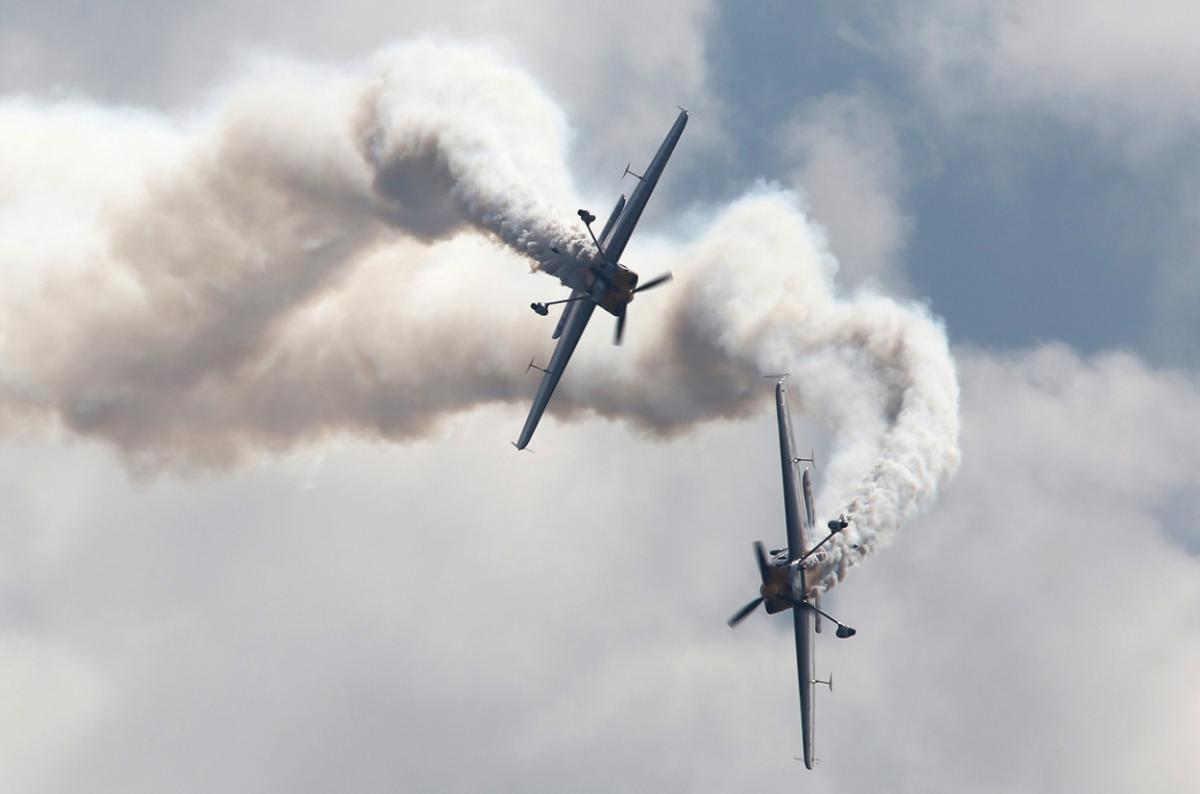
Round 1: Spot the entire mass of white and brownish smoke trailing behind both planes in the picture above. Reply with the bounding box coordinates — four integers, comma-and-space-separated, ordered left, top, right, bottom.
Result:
0, 43, 958, 587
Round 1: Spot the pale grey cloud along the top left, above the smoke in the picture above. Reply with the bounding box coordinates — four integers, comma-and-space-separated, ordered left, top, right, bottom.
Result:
0, 0, 722, 187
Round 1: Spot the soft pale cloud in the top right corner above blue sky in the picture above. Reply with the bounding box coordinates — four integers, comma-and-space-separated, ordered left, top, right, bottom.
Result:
881, 0, 1200, 160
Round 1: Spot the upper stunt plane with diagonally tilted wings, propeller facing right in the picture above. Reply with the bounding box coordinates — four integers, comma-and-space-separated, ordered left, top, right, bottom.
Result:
512, 108, 688, 450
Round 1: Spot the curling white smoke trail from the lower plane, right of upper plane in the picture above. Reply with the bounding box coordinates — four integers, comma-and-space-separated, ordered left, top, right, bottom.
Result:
590, 188, 959, 589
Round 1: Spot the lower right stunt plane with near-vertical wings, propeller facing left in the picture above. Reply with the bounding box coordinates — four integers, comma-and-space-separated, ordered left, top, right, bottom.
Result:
728, 374, 856, 769
